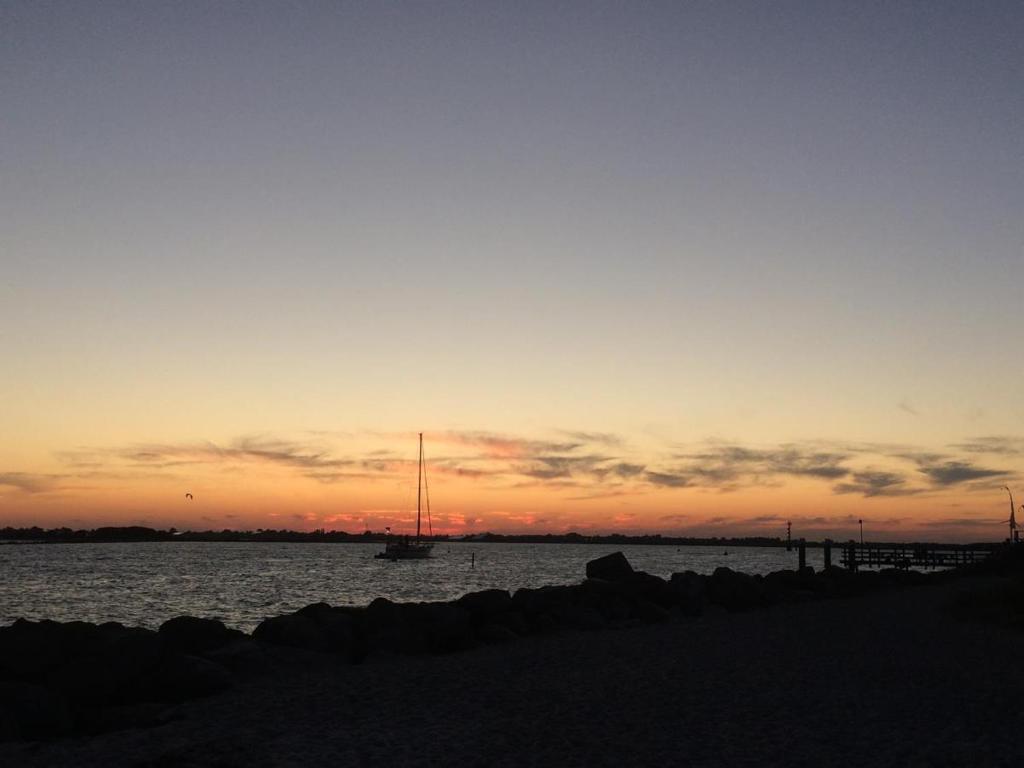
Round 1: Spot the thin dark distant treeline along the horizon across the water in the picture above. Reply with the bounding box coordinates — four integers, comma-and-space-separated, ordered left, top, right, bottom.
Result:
0, 525, 998, 548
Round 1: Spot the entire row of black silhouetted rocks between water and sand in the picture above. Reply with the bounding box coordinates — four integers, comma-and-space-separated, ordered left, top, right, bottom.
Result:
0, 545, 1024, 755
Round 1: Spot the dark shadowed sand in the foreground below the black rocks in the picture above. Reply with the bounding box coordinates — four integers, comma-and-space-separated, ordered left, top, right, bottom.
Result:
0, 579, 1024, 766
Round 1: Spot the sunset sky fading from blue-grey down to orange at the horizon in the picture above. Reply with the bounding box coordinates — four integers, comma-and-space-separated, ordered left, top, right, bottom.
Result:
0, 0, 1024, 541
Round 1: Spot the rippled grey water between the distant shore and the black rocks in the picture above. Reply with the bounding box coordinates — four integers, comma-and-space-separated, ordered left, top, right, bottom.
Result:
0, 542, 821, 631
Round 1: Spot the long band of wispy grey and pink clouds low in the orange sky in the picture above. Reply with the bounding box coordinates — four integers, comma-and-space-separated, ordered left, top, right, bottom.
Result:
29, 430, 1024, 501
